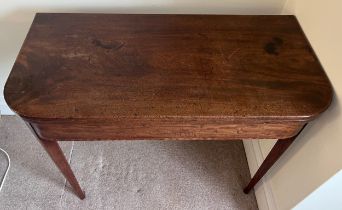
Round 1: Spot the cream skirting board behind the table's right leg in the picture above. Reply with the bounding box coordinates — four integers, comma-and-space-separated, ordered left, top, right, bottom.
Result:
243, 140, 279, 210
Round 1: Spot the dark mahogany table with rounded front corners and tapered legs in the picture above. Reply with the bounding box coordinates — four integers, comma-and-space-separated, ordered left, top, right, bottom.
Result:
4, 13, 332, 199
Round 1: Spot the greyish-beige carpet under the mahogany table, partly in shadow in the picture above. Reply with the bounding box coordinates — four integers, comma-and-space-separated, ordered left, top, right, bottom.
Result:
0, 116, 257, 210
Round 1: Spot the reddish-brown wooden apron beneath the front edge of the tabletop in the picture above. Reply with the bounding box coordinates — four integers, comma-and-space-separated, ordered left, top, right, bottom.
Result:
30, 119, 304, 141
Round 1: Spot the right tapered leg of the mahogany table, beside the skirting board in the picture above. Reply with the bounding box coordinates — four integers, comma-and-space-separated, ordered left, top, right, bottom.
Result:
243, 125, 305, 194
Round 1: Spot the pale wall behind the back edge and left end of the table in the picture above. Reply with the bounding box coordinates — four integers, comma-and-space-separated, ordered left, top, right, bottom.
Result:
0, 0, 285, 114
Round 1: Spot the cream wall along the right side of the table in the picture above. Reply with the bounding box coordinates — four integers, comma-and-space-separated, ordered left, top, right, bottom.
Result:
245, 0, 342, 209
